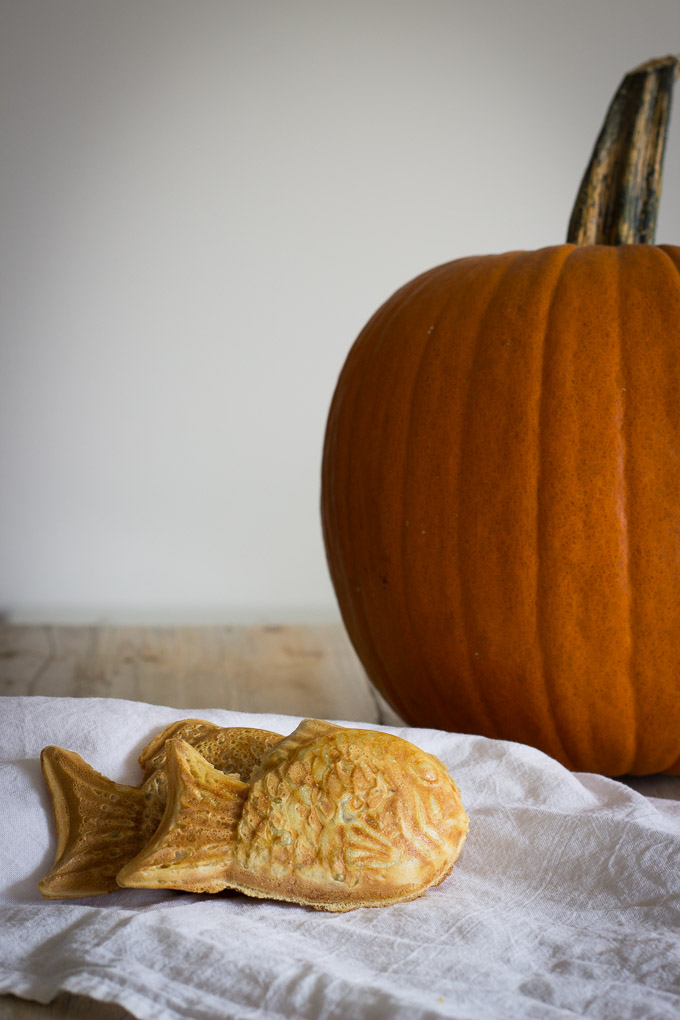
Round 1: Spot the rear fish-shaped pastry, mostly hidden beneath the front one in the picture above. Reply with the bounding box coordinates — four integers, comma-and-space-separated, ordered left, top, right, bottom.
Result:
38, 719, 282, 900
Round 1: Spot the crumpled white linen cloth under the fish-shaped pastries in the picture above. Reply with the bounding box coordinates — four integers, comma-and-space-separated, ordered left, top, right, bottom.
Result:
0, 697, 680, 1020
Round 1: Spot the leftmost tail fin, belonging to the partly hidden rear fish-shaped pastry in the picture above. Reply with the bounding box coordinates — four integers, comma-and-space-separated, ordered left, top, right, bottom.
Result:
38, 747, 146, 900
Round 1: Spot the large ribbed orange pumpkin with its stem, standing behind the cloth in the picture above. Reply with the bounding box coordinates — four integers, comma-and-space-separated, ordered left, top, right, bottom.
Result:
322, 58, 680, 775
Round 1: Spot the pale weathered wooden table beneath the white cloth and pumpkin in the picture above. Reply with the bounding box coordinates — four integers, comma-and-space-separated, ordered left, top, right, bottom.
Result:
0, 624, 680, 1020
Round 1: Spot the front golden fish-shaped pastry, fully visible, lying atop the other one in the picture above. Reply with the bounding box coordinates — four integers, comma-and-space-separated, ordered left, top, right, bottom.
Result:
117, 719, 468, 911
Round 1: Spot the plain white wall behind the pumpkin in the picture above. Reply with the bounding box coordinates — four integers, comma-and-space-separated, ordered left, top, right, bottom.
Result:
0, 0, 680, 622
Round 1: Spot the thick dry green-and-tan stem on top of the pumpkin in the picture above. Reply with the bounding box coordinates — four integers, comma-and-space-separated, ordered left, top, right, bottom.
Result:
567, 56, 680, 245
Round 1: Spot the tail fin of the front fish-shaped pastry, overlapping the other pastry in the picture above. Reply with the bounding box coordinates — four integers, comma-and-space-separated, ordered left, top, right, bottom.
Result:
117, 738, 250, 893
